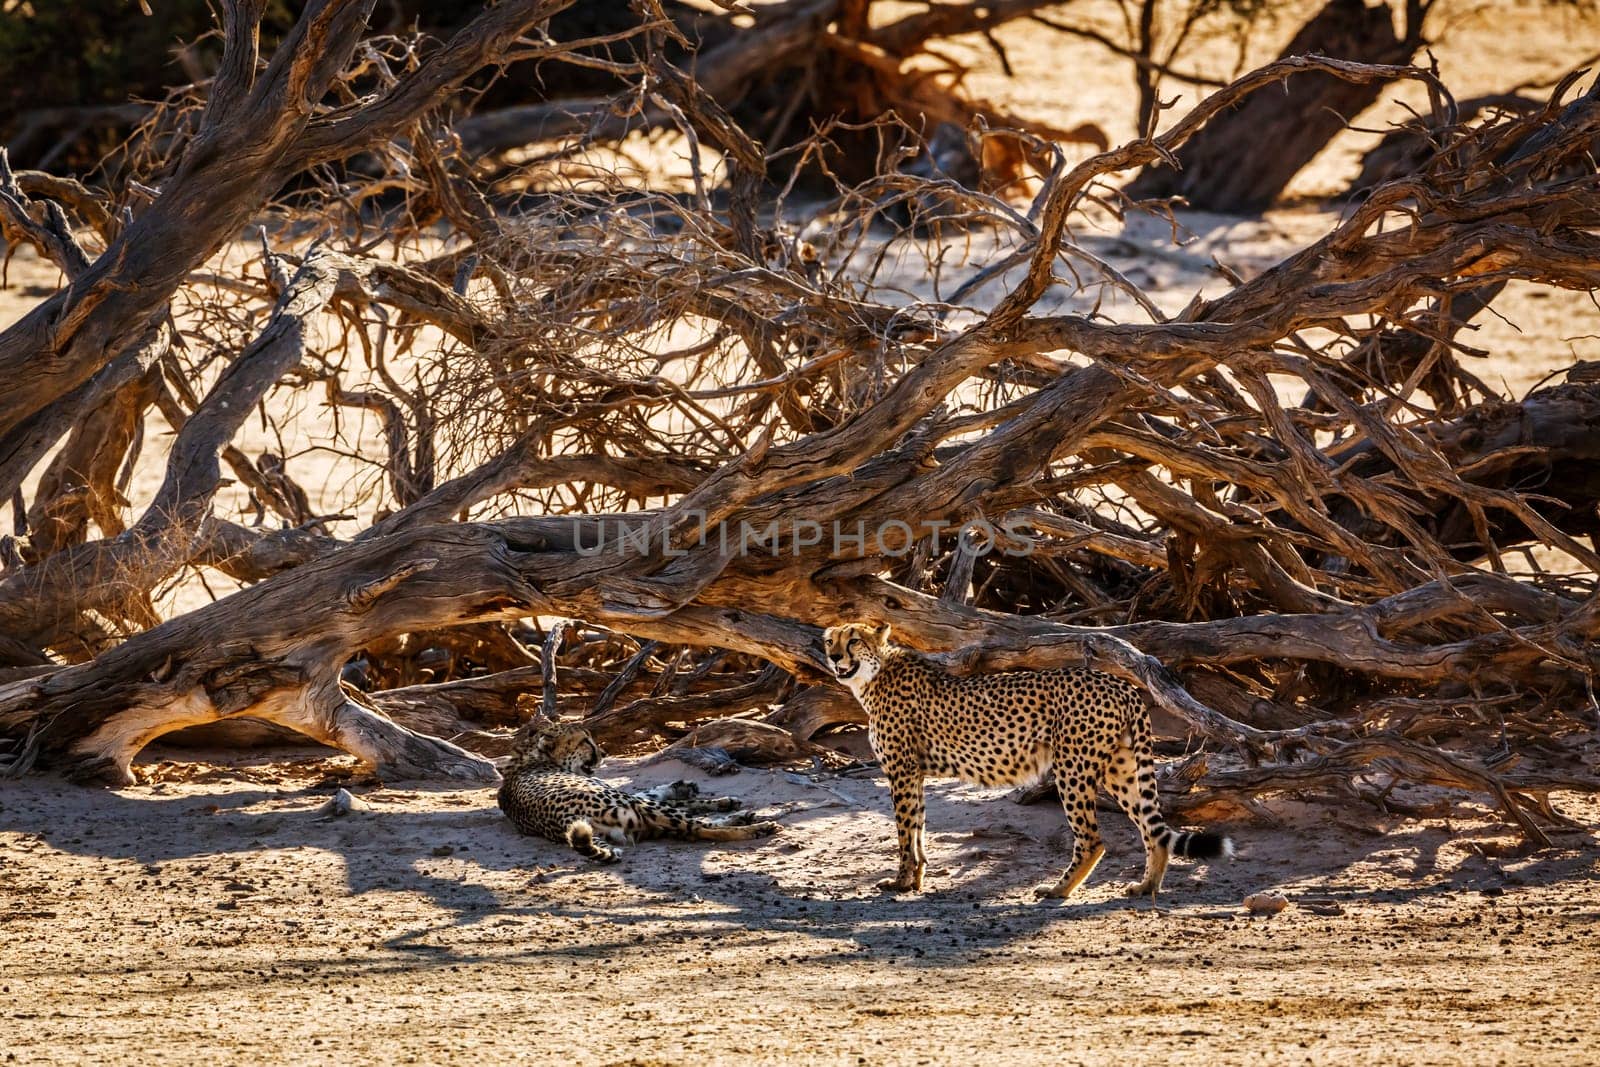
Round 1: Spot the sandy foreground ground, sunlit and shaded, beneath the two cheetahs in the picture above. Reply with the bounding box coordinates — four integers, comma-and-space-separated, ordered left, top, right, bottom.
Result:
0, 753, 1600, 1064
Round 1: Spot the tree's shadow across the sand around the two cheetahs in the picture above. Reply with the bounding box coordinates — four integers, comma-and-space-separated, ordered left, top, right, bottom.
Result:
0, 751, 1595, 966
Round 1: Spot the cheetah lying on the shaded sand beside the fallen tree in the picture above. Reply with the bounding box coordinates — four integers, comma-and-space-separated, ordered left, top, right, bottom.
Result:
499, 718, 778, 864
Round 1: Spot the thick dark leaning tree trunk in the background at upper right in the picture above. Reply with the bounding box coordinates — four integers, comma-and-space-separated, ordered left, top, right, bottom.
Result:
1126, 0, 1426, 214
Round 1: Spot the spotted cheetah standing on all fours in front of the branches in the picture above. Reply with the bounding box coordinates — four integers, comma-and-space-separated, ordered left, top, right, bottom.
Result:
822, 624, 1234, 897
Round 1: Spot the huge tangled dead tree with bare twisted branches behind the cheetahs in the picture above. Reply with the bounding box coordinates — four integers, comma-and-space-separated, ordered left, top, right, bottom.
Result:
0, 3, 1600, 837
